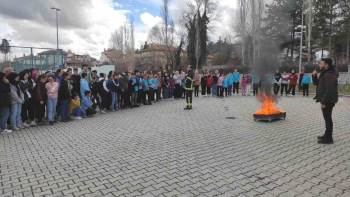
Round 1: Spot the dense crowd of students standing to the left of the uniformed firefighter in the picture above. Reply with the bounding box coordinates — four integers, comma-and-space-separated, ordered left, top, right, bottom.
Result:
0, 66, 201, 133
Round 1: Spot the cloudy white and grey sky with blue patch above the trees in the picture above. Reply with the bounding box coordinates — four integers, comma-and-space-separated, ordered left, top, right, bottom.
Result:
0, 0, 238, 58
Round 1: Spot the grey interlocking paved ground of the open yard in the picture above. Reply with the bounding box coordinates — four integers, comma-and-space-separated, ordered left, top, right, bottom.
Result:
0, 97, 350, 197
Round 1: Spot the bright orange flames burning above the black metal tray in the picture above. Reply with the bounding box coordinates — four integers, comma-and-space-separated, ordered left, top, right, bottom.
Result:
255, 93, 284, 115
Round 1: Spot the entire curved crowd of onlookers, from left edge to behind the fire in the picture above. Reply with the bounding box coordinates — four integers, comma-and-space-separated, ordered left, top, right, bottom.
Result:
0, 63, 317, 132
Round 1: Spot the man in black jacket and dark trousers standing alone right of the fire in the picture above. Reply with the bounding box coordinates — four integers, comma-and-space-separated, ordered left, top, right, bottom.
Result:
316, 58, 338, 144
